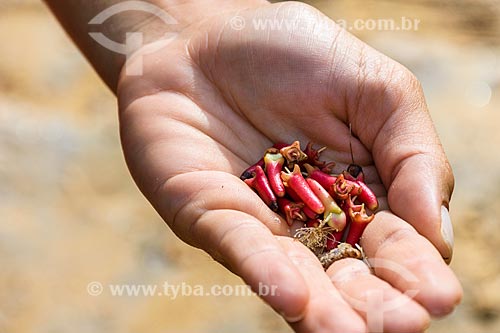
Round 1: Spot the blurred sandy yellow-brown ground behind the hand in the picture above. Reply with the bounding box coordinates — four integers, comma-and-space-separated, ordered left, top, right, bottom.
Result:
0, 0, 500, 333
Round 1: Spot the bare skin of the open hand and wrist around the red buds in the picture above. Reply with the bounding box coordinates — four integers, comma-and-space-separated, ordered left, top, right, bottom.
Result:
47, 0, 462, 332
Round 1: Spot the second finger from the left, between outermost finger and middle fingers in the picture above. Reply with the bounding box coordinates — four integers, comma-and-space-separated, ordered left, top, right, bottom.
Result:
278, 237, 366, 333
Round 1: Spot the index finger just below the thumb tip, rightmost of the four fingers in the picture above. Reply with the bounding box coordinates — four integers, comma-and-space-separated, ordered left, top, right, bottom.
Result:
361, 211, 462, 316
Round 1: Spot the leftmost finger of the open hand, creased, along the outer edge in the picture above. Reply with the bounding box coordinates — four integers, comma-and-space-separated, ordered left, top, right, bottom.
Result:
154, 171, 308, 320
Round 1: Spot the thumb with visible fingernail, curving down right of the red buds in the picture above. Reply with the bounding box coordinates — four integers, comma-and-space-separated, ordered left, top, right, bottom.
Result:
363, 71, 454, 263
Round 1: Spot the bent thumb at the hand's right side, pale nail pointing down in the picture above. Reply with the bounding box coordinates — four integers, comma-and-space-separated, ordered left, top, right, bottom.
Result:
353, 61, 454, 262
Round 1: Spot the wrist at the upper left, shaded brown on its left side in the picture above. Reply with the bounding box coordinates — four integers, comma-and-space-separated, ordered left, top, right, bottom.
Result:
45, 0, 268, 92
